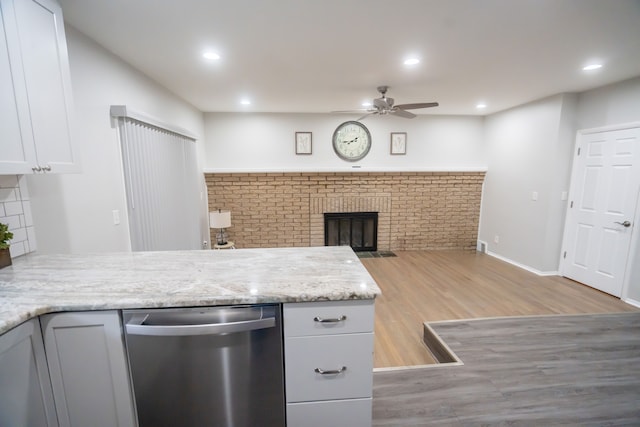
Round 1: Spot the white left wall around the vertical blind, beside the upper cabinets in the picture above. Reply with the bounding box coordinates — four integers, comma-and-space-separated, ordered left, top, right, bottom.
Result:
27, 27, 206, 253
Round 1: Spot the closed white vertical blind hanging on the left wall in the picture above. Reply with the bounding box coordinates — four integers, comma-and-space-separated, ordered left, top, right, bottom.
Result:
118, 117, 201, 251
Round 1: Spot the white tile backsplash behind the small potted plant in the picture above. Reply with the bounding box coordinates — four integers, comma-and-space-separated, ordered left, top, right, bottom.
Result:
0, 175, 37, 258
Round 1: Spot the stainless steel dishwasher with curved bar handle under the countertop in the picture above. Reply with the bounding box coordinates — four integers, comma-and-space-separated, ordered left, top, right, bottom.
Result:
123, 304, 285, 427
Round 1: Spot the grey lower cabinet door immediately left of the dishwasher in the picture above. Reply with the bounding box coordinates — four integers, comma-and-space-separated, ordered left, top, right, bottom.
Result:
41, 311, 136, 427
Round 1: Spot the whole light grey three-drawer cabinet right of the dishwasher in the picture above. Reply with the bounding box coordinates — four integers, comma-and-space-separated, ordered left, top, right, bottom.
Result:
283, 300, 374, 427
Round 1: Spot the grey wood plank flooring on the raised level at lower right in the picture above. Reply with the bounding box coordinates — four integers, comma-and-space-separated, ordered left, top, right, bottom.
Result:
373, 312, 640, 427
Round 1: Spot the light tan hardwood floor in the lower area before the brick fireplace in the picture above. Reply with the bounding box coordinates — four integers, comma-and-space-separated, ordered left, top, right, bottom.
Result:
362, 251, 640, 368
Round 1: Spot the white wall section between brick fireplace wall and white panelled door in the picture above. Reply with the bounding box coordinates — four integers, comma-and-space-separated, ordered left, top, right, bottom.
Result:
479, 95, 576, 274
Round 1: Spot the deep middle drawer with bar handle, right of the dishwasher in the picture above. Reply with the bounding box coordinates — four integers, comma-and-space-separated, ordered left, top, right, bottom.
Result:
285, 333, 373, 402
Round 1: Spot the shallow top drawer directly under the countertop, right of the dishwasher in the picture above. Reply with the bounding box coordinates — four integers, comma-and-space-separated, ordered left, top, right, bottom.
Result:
283, 300, 374, 337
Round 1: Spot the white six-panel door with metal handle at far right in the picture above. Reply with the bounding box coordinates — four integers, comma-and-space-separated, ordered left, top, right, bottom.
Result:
561, 127, 640, 297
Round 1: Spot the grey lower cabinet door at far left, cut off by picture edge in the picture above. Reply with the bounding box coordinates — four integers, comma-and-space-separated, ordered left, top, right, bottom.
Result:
0, 319, 58, 427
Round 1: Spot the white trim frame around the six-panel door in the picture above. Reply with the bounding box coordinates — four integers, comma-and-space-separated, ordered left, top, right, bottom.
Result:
559, 122, 640, 305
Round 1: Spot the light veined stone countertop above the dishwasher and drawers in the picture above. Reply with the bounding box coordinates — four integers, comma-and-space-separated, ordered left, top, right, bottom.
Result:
0, 246, 380, 334
